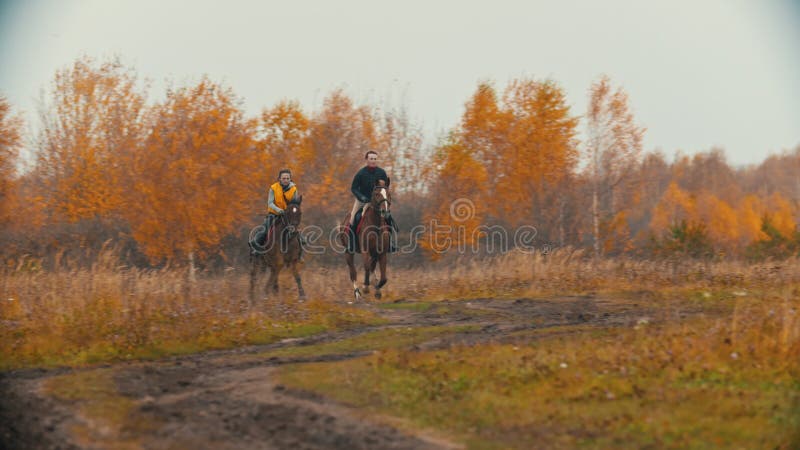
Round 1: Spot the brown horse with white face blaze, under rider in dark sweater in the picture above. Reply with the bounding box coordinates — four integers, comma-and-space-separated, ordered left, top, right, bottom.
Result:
339, 180, 392, 301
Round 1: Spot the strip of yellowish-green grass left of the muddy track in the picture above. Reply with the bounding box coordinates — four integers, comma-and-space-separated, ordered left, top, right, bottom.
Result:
0, 298, 386, 370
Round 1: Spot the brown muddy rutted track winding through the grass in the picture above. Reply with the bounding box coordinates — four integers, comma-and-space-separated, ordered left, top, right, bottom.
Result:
0, 296, 708, 450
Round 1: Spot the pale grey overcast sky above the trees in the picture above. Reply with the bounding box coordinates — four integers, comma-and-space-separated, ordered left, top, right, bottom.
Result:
0, 0, 800, 165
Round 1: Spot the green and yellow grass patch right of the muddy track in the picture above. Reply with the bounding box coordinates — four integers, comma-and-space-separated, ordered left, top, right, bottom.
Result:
279, 299, 800, 449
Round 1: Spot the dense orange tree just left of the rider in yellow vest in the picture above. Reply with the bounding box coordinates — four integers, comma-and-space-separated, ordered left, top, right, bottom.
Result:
126, 78, 264, 268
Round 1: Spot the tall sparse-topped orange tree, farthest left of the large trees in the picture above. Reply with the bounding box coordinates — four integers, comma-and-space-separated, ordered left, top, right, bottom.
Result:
36, 57, 145, 229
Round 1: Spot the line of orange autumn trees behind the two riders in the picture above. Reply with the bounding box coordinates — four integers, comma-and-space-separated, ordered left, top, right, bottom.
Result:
0, 57, 800, 266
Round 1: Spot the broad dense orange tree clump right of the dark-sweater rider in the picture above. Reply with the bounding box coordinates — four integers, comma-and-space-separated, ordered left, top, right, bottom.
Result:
426, 79, 578, 256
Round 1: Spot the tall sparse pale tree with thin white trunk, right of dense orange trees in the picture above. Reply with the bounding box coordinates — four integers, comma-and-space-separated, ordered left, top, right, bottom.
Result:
586, 76, 644, 255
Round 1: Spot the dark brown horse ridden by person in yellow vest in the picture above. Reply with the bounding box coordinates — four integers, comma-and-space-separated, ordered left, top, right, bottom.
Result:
250, 196, 306, 300
